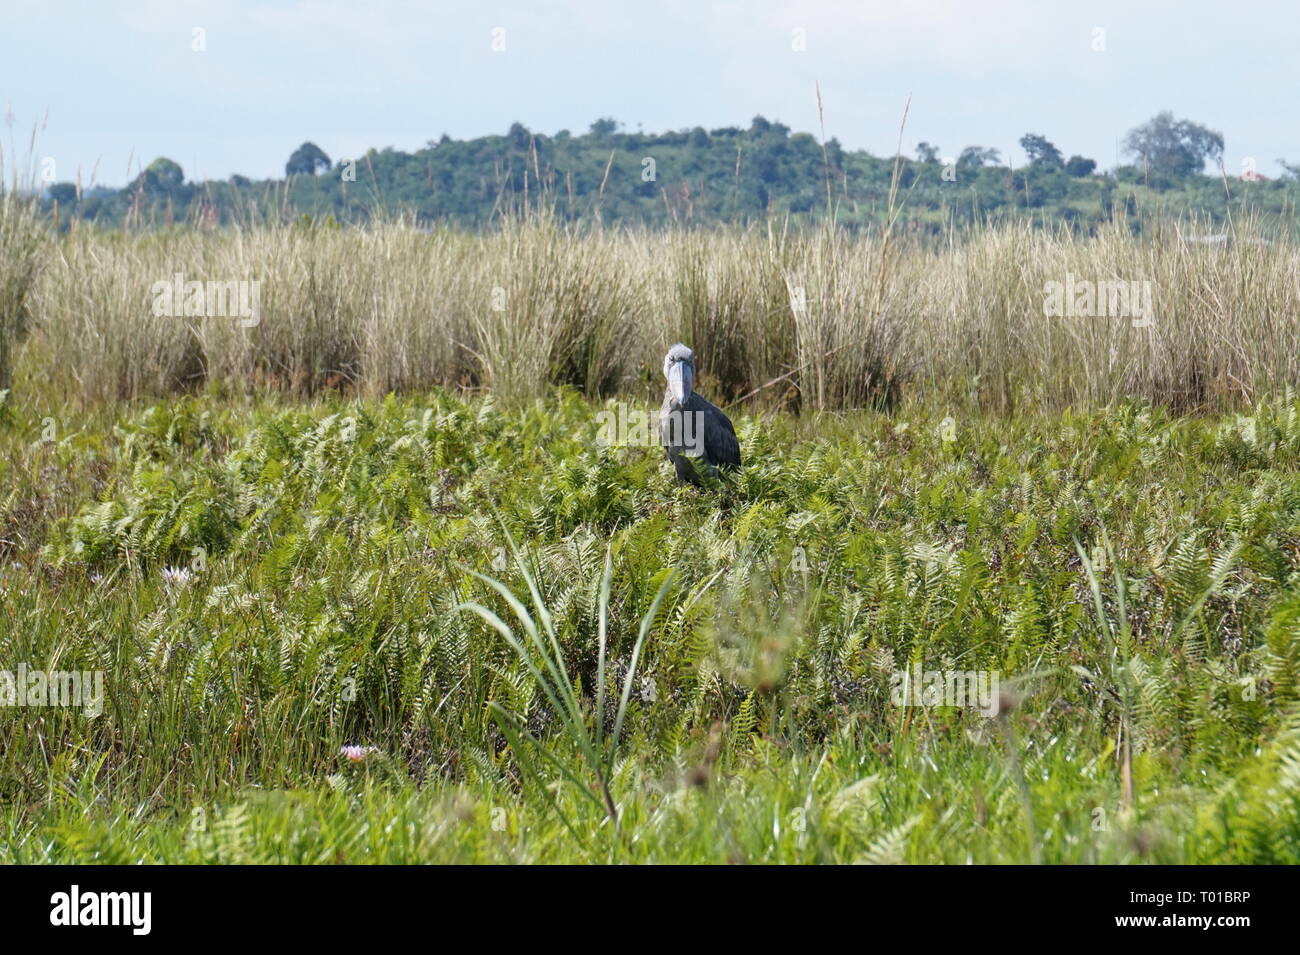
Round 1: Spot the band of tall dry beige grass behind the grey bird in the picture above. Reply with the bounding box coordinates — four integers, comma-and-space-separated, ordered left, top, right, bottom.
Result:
15, 213, 1300, 412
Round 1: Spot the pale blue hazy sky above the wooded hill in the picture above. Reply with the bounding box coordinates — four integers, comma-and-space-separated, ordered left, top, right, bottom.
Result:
0, 0, 1300, 186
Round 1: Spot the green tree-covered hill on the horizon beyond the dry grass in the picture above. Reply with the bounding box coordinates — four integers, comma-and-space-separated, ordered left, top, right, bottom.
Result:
44, 113, 1300, 231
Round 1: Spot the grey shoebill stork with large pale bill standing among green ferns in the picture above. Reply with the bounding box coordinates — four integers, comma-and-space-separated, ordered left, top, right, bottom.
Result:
659, 344, 740, 485
